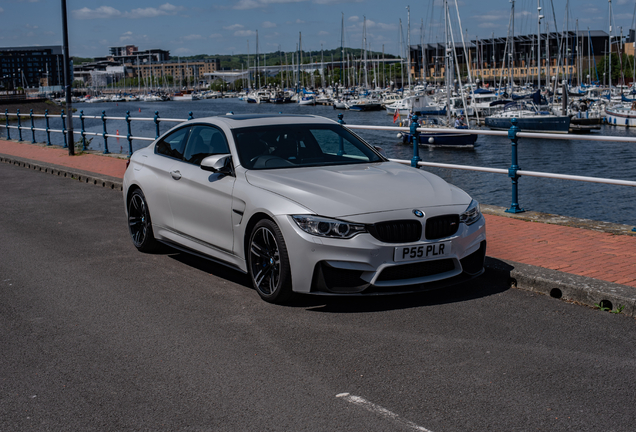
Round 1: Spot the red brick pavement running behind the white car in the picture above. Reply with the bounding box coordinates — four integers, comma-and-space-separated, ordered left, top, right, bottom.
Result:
0, 140, 636, 287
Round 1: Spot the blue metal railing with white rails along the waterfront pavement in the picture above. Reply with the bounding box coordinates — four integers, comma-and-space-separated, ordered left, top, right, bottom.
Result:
0, 110, 636, 232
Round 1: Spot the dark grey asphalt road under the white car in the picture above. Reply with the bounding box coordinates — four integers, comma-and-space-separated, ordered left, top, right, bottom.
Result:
0, 164, 636, 432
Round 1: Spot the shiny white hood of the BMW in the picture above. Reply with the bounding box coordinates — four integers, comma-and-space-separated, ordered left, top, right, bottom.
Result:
246, 162, 470, 217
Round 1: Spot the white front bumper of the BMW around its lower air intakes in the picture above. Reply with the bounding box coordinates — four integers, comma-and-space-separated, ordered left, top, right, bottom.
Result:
277, 210, 486, 295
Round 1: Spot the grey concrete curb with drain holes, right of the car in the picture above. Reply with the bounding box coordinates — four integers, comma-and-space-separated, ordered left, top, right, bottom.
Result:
485, 257, 636, 317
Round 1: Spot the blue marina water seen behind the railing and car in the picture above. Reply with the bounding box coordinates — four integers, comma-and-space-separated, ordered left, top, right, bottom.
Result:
27, 98, 636, 226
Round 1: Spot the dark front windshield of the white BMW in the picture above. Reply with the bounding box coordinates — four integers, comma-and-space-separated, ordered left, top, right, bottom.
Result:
233, 124, 383, 170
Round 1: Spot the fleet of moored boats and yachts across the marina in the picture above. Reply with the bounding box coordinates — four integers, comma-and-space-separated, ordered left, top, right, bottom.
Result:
74, 85, 636, 147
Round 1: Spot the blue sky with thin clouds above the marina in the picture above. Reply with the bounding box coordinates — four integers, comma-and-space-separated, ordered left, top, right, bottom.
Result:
0, 0, 635, 57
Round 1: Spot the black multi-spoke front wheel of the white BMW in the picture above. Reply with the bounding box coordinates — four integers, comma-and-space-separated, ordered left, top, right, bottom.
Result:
247, 219, 292, 303
